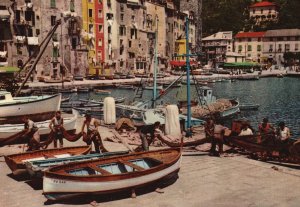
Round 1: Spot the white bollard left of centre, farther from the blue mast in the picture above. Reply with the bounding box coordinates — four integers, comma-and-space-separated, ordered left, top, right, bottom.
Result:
103, 97, 116, 124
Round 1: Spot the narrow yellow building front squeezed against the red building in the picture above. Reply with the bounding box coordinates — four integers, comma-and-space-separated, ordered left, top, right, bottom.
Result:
82, 0, 96, 75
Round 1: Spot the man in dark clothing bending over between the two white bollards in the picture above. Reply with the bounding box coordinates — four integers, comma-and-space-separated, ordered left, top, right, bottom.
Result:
140, 121, 160, 151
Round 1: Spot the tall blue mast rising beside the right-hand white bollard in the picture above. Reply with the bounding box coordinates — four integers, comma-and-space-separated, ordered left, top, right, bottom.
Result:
185, 16, 192, 136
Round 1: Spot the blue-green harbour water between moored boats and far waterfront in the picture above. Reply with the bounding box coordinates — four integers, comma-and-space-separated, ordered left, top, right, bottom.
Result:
68, 77, 300, 138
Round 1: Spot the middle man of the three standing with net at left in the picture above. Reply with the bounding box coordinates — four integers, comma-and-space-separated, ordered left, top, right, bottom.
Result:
49, 111, 64, 148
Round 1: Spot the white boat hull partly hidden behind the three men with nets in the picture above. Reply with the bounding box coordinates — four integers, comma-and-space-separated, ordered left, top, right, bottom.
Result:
0, 113, 78, 142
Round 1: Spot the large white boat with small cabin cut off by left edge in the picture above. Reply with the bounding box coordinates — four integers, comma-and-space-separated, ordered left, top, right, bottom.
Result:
0, 91, 61, 124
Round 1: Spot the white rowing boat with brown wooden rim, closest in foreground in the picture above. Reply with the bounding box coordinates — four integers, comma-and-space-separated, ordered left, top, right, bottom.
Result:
43, 148, 181, 200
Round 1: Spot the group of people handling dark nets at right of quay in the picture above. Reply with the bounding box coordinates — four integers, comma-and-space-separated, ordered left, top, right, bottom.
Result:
205, 118, 291, 156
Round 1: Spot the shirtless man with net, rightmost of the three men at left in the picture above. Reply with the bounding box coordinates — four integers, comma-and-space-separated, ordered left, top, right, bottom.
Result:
81, 114, 102, 153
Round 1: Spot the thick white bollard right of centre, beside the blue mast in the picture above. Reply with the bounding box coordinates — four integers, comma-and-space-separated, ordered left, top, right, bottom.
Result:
165, 105, 181, 137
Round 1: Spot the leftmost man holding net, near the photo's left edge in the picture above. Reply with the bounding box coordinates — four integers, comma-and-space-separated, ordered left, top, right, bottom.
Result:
22, 116, 40, 151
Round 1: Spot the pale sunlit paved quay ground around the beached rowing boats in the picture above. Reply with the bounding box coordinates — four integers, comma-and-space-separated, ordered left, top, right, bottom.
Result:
0, 139, 300, 207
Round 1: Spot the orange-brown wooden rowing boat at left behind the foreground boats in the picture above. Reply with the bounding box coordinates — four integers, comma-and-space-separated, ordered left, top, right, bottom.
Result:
4, 146, 91, 175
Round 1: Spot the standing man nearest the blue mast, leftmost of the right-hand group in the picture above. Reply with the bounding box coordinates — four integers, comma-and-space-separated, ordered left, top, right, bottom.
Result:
209, 119, 227, 157
